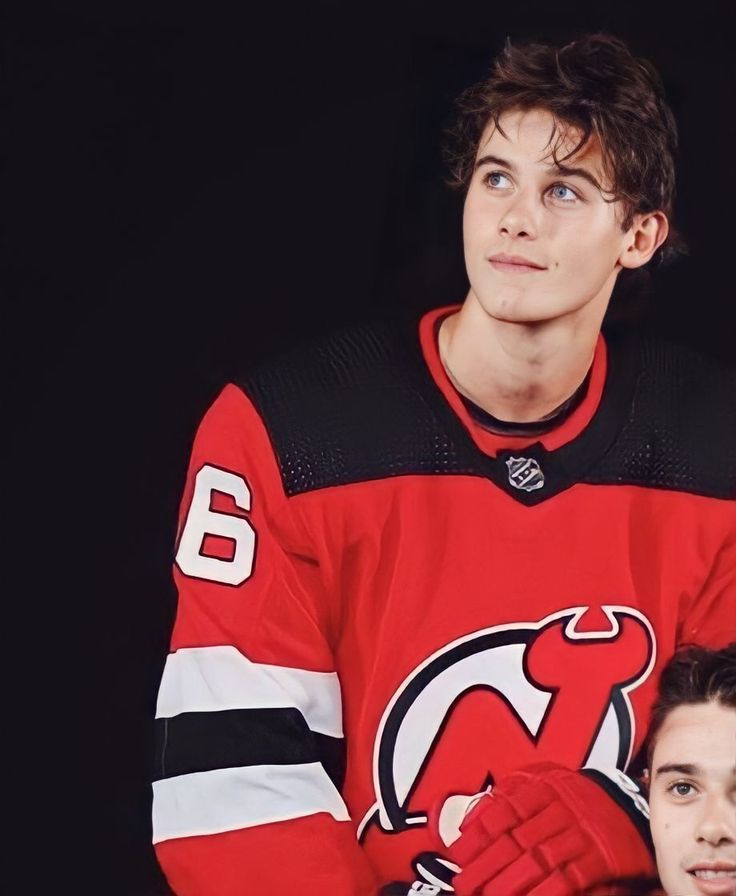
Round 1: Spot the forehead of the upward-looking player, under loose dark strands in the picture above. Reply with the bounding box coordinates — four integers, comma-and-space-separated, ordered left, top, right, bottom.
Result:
476, 109, 604, 174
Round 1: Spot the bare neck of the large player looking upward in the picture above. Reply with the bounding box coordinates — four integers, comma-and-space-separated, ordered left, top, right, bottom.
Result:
439, 290, 602, 423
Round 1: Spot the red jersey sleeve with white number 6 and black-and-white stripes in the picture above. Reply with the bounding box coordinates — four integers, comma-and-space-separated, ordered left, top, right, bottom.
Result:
153, 385, 377, 896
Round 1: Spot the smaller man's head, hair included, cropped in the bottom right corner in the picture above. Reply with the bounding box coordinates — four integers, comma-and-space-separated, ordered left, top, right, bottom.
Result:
648, 643, 736, 896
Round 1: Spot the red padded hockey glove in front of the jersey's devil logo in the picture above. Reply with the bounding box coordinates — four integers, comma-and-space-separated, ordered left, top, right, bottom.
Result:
449, 763, 656, 896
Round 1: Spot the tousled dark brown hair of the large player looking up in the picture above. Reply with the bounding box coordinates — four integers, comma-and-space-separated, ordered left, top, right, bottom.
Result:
445, 34, 686, 261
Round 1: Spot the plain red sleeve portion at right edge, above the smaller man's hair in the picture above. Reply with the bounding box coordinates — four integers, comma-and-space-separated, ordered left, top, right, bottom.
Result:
678, 520, 736, 649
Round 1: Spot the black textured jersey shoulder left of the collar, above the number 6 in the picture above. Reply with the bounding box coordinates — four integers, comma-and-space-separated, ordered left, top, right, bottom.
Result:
235, 312, 466, 496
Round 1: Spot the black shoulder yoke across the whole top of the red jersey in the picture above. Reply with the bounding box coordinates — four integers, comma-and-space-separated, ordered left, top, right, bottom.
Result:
236, 318, 736, 505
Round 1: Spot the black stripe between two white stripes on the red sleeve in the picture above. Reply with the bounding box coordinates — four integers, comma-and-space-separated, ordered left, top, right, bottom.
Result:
155, 707, 345, 790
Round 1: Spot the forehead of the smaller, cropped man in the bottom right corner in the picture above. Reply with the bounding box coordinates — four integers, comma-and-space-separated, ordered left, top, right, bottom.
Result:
652, 702, 736, 769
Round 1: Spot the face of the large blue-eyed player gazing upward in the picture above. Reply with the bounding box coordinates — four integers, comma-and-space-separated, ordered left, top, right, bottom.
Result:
463, 109, 631, 323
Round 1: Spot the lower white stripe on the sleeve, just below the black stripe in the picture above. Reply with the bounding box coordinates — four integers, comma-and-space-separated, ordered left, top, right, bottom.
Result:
153, 762, 350, 843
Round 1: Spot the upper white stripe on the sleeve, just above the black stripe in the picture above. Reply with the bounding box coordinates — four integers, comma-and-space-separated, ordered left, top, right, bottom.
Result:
156, 645, 343, 737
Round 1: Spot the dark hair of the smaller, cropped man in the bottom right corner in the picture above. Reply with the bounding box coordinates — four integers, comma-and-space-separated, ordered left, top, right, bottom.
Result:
646, 641, 736, 766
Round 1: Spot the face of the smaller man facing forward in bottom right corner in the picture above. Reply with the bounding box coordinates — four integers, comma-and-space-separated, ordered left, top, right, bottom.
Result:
649, 702, 736, 896
